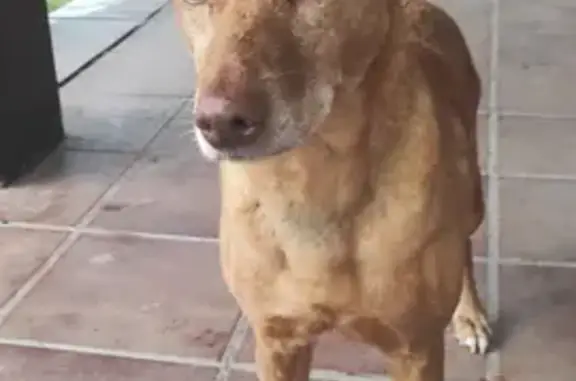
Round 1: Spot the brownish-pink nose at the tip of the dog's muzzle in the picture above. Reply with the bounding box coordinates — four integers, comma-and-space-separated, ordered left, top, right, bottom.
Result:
196, 95, 264, 149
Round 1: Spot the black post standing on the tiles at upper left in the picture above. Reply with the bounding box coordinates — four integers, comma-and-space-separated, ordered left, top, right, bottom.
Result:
0, 0, 64, 186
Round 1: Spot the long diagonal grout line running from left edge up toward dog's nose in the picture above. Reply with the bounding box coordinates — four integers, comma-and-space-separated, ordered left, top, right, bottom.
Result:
0, 101, 185, 327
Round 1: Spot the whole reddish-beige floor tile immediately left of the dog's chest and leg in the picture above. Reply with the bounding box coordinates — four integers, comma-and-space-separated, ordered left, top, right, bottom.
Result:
0, 236, 238, 358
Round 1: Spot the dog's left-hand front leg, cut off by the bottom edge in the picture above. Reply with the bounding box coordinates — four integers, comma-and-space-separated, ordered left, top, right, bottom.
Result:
255, 329, 313, 381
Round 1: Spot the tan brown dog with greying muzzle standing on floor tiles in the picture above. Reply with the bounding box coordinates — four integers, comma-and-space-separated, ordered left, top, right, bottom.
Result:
175, 0, 489, 381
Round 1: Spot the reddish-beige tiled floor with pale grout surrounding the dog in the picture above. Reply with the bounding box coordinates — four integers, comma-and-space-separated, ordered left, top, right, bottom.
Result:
0, 0, 576, 381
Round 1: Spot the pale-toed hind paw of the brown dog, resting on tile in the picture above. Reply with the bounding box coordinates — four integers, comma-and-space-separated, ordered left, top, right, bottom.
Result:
452, 314, 492, 355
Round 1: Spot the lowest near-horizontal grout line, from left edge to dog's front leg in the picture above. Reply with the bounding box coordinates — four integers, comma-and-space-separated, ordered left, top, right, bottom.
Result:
0, 338, 220, 368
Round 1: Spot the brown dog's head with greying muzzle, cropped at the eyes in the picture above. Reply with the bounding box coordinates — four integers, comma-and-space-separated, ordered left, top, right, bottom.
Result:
174, 0, 391, 159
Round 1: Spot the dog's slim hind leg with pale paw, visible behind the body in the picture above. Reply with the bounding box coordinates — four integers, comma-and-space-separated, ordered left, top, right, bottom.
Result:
452, 240, 491, 354
